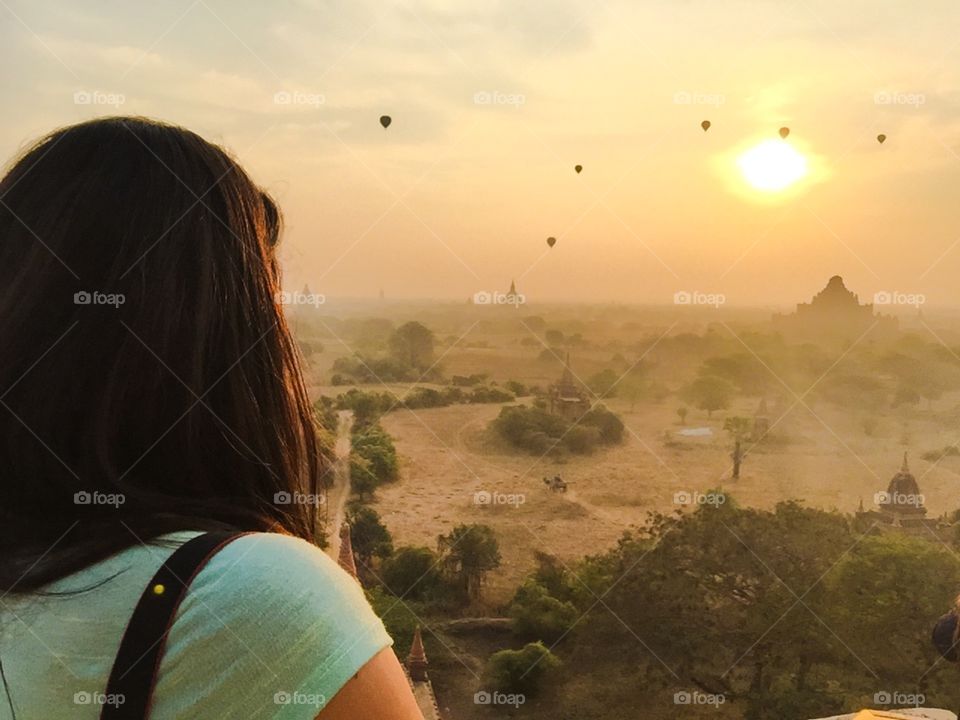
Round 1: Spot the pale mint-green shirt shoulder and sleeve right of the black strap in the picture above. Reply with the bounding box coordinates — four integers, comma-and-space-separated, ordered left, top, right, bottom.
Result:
154, 533, 391, 719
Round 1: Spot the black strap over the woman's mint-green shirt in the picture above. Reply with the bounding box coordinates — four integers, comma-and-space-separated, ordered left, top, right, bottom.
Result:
100, 532, 248, 720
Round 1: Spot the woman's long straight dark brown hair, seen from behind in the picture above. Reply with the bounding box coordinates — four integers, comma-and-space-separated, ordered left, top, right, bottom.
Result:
0, 117, 325, 592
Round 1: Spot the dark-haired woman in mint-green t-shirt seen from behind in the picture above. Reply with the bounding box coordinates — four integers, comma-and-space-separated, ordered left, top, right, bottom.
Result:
0, 118, 421, 720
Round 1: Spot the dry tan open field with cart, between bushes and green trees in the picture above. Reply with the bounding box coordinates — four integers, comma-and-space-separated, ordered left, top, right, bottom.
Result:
366, 398, 960, 605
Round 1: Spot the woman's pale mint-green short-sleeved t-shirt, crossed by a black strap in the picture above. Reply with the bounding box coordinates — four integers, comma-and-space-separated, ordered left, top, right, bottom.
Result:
0, 532, 391, 720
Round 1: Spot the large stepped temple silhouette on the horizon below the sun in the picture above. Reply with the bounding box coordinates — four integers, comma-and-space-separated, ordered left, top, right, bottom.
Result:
773, 275, 899, 342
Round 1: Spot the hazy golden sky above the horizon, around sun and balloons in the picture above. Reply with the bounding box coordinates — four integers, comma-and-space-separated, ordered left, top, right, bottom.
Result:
0, 0, 960, 305
